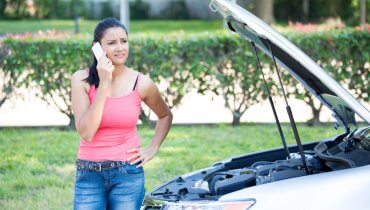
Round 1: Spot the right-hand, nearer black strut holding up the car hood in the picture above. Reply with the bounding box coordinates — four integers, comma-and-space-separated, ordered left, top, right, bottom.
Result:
265, 39, 310, 175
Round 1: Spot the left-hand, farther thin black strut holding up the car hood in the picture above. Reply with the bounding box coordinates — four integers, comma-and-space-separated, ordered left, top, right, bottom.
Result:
251, 42, 290, 159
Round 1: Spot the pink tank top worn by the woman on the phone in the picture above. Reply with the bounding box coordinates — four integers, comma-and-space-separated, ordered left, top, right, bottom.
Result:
78, 69, 141, 161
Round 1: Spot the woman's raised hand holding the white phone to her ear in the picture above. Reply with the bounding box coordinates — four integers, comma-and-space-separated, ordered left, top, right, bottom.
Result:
96, 54, 114, 87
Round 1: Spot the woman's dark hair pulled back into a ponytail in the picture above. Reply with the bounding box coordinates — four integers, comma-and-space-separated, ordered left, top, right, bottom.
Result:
84, 17, 127, 88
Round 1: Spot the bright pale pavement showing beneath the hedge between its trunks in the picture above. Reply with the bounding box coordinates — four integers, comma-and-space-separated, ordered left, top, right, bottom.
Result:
0, 88, 348, 126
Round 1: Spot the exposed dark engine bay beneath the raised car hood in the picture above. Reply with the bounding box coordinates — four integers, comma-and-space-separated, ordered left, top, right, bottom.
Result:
150, 127, 370, 201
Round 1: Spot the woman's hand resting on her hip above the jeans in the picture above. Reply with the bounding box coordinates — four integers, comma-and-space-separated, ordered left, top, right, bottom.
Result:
127, 146, 158, 167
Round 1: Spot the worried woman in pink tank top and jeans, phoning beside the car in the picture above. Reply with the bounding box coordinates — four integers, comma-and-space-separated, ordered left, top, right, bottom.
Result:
72, 18, 172, 210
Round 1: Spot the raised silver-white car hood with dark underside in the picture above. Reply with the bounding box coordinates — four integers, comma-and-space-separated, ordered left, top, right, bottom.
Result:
210, 0, 370, 127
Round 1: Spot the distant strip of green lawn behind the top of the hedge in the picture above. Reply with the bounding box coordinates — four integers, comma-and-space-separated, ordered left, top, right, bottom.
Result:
0, 20, 223, 34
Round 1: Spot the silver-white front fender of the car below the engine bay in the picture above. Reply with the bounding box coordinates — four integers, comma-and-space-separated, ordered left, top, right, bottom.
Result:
220, 165, 370, 210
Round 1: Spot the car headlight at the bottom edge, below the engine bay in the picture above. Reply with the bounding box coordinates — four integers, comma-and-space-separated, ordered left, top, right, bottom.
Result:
161, 199, 256, 210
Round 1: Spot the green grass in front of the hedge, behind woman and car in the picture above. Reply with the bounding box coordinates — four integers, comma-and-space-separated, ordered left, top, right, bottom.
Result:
0, 124, 341, 209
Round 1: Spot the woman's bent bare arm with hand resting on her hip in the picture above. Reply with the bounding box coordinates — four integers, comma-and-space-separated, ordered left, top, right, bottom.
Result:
127, 74, 172, 167
